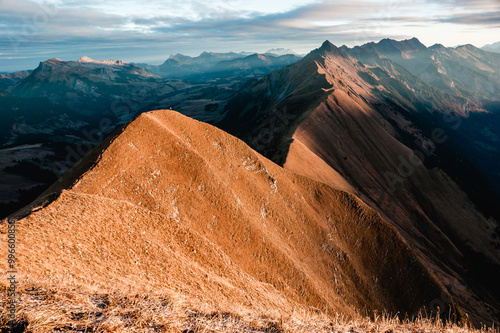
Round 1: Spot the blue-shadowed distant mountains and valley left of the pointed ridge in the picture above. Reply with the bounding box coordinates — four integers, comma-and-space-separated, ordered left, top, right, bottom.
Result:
0, 52, 299, 215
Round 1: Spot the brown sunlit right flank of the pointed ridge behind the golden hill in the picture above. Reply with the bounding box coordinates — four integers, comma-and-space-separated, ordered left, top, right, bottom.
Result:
282, 54, 500, 323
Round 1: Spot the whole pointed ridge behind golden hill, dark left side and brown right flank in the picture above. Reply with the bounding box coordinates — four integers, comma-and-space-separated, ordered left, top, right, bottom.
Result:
220, 42, 500, 322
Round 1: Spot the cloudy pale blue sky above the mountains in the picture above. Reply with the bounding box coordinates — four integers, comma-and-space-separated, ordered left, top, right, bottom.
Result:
0, 0, 500, 72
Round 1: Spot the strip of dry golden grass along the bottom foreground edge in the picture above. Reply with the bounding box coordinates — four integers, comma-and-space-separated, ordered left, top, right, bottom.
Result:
0, 286, 500, 333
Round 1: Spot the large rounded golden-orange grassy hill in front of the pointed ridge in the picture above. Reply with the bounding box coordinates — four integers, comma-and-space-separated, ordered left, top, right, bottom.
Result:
0, 111, 452, 322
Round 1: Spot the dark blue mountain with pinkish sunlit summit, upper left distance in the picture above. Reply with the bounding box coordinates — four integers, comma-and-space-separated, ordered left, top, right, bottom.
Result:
11, 57, 179, 122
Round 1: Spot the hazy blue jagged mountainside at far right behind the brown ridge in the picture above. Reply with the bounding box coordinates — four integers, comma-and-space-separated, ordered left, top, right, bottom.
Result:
342, 40, 500, 198
